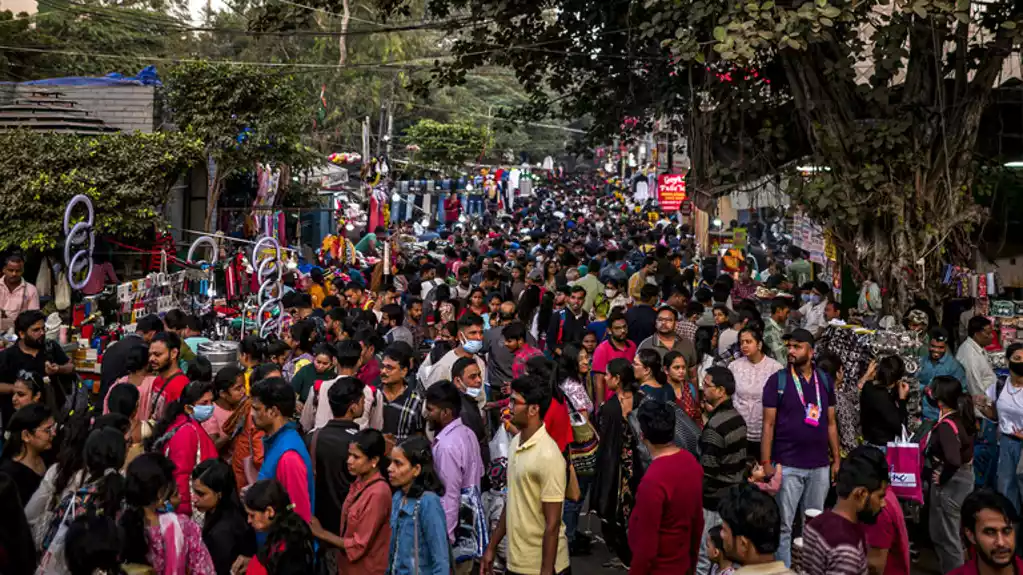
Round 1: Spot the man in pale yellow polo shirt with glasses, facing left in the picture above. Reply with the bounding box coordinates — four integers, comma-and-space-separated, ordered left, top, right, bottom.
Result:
482, 375, 569, 575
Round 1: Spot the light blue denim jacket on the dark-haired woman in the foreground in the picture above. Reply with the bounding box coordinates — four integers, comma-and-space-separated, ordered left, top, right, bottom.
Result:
387, 490, 451, 575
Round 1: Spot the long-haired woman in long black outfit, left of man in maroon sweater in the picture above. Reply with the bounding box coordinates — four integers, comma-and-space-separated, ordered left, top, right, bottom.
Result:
591, 352, 656, 565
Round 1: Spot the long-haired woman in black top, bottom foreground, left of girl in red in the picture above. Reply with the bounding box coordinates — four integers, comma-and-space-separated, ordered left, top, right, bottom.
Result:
191, 459, 256, 575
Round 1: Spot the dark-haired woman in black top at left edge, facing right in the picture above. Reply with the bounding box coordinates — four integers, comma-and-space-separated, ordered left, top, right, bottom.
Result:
0, 403, 56, 505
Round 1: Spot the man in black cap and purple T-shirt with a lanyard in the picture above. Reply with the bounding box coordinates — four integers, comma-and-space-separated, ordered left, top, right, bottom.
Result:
760, 328, 841, 566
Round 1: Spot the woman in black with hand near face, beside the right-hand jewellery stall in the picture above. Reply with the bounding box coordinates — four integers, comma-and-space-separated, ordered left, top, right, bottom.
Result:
859, 355, 909, 451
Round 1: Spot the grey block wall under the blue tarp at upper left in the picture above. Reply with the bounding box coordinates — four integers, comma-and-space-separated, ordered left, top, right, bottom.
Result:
15, 84, 155, 133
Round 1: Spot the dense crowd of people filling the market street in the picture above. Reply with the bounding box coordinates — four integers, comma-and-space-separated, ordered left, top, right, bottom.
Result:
0, 175, 1023, 575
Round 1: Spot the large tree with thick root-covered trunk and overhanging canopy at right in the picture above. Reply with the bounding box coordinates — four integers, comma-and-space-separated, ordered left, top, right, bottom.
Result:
379, 0, 1023, 308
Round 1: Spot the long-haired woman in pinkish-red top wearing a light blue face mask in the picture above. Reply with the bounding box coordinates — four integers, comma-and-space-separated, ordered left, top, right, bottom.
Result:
146, 382, 217, 515
